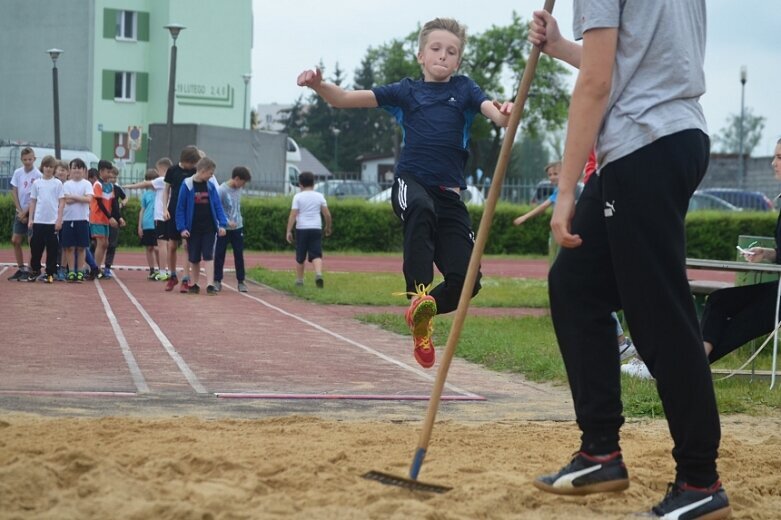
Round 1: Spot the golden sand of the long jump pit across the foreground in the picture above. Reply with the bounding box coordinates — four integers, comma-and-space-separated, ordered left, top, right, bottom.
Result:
0, 415, 781, 520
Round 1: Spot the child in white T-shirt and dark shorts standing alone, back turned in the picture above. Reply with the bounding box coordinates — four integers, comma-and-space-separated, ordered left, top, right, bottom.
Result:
285, 172, 331, 289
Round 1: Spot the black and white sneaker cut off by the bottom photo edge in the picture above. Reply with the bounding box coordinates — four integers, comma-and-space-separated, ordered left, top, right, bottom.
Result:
646, 480, 732, 520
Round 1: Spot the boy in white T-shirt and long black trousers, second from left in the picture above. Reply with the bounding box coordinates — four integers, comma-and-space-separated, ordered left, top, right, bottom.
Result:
27, 155, 65, 283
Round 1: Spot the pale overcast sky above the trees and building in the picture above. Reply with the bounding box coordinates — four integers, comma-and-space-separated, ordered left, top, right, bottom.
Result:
251, 0, 781, 157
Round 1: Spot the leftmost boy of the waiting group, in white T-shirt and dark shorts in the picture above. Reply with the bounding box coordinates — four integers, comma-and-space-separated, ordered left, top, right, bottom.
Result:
8, 147, 41, 281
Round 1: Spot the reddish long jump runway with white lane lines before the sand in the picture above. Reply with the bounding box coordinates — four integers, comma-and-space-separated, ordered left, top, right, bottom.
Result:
0, 267, 494, 400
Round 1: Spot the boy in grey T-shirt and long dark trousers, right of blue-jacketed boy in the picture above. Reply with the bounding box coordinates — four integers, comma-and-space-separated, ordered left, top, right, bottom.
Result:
214, 166, 252, 292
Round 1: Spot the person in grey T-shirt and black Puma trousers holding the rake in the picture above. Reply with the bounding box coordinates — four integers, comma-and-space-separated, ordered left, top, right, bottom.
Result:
529, 0, 730, 520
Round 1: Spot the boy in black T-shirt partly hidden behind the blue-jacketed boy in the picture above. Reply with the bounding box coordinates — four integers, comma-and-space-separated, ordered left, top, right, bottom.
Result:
163, 146, 201, 292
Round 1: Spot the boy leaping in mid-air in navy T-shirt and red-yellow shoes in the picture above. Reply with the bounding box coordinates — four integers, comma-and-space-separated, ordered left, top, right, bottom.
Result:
298, 18, 512, 368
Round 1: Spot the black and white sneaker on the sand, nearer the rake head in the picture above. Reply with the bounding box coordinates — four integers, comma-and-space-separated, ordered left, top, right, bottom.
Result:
534, 451, 629, 495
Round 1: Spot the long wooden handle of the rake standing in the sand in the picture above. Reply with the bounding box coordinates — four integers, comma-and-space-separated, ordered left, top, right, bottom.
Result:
410, 0, 555, 479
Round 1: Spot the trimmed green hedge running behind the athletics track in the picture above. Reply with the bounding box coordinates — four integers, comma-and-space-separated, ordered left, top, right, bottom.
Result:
0, 195, 776, 260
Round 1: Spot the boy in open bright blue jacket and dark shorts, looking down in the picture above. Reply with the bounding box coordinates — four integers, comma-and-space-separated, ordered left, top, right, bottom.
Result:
176, 157, 228, 296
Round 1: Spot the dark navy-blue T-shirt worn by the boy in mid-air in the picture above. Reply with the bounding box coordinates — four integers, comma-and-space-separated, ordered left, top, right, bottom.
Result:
372, 76, 488, 189
